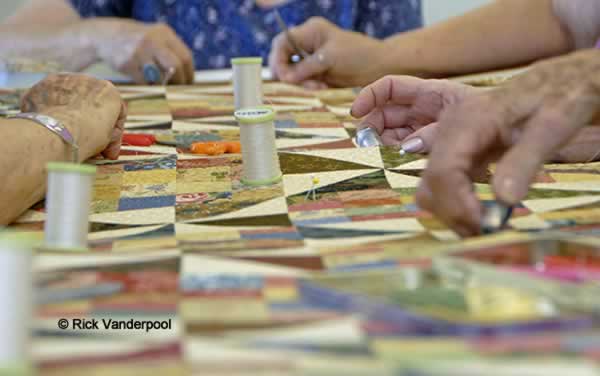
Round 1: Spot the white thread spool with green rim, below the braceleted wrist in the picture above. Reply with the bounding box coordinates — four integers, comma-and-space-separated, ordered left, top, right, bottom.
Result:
44, 162, 96, 251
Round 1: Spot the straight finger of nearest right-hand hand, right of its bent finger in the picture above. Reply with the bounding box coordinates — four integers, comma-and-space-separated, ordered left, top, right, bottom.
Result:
493, 93, 599, 205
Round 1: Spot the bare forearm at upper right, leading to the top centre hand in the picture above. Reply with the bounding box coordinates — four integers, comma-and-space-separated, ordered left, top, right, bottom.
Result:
383, 0, 572, 77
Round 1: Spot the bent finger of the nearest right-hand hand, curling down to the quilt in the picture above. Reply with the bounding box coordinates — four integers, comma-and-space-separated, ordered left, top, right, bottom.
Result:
423, 95, 515, 235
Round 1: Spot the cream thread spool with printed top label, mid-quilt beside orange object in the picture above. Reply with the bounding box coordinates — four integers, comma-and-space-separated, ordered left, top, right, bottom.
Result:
235, 107, 281, 186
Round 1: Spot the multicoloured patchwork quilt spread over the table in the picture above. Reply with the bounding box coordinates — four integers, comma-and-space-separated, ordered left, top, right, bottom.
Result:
7, 72, 600, 375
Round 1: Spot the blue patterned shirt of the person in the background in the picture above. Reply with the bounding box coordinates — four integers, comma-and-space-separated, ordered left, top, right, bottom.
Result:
71, 0, 422, 69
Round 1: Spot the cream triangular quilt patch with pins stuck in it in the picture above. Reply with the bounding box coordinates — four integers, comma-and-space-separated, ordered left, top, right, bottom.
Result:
282, 168, 378, 197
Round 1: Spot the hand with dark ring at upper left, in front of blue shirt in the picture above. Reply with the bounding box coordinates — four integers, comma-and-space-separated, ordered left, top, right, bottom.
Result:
83, 19, 194, 84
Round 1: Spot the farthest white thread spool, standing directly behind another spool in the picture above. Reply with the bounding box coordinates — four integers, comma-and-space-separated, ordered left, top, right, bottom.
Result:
231, 57, 263, 111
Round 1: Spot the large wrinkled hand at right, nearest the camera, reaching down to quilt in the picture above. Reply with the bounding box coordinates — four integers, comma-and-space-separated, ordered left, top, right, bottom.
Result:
417, 50, 600, 236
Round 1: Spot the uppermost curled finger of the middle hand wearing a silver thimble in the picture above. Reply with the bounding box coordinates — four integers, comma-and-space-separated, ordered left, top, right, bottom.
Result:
350, 76, 426, 118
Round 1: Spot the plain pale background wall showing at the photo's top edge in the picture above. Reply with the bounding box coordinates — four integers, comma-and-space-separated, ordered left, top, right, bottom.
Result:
0, 0, 490, 24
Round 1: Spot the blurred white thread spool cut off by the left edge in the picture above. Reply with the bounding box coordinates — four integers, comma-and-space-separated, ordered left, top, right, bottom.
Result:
0, 232, 34, 375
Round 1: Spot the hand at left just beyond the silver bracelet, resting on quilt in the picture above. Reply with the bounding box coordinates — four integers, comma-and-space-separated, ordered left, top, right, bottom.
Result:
21, 74, 127, 159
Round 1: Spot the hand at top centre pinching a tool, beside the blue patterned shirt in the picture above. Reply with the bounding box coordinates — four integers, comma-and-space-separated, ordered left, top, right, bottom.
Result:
269, 17, 382, 88
